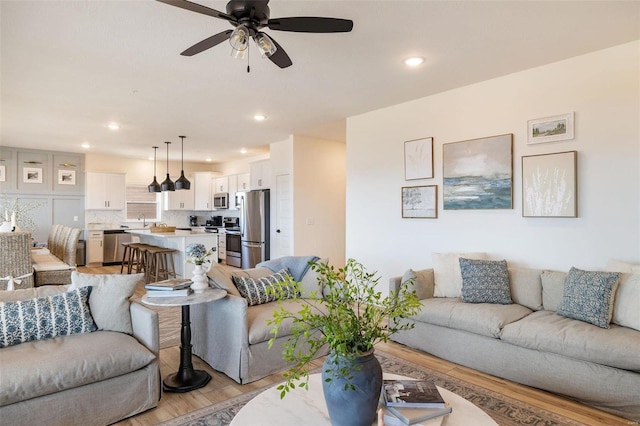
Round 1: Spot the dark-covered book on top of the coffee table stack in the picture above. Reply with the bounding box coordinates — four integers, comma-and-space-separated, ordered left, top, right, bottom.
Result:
382, 380, 445, 408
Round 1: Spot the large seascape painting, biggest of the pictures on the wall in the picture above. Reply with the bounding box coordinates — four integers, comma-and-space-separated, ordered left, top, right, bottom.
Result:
442, 133, 513, 210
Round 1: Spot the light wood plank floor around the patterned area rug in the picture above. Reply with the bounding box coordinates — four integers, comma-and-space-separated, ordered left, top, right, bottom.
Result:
79, 266, 637, 426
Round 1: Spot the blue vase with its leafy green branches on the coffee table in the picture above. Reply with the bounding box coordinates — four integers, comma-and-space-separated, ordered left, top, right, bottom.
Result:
268, 259, 421, 426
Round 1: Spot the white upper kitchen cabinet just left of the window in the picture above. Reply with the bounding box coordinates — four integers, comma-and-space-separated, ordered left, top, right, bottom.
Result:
86, 172, 126, 210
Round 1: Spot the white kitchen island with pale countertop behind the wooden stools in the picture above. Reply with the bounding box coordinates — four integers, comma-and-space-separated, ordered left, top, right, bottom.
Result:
126, 229, 218, 278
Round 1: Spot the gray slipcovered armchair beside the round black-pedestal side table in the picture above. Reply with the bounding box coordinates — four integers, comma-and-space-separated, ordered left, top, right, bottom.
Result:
191, 258, 327, 384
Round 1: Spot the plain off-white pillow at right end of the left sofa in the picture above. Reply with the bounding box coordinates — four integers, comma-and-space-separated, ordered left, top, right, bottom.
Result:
70, 271, 144, 334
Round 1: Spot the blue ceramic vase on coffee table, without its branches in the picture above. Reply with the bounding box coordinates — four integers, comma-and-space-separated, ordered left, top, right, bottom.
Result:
322, 350, 382, 426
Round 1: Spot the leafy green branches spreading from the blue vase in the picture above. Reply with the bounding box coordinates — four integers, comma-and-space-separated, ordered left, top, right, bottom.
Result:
268, 259, 421, 398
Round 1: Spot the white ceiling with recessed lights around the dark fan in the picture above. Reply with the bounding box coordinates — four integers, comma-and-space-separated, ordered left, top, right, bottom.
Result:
0, 0, 640, 162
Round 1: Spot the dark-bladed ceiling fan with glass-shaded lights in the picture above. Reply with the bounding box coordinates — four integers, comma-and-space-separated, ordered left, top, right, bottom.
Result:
157, 0, 353, 70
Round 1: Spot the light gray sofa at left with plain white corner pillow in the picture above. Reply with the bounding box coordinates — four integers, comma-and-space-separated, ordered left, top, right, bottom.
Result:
0, 273, 160, 426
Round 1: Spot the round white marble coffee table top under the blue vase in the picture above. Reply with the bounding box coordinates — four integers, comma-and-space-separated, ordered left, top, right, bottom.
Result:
231, 373, 497, 426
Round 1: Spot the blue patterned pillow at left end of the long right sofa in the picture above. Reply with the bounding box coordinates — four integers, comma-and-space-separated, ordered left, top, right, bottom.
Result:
460, 258, 513, 305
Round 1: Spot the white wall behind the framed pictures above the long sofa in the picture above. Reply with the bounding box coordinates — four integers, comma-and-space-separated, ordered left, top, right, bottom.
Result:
346, 41, 640, 289
